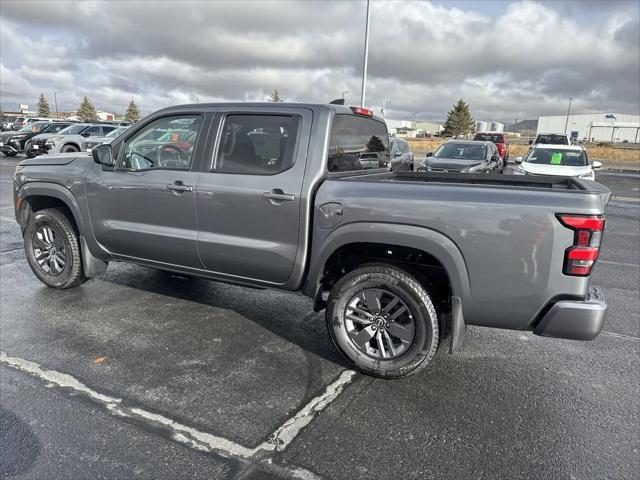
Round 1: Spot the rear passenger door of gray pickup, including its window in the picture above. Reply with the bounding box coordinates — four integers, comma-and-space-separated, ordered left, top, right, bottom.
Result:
196, 107, 312, 284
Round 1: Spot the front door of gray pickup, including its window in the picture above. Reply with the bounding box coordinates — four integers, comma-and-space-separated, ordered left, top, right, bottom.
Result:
87, 113, 204, 268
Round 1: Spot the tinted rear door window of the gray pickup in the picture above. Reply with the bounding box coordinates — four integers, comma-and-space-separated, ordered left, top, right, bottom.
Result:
215, 115, 300, 175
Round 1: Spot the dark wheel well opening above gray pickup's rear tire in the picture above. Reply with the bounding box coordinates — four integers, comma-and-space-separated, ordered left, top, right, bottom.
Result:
320, 243, 451, 336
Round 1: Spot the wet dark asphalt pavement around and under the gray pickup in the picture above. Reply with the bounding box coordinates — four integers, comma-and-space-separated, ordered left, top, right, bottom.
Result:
0, 158, 640, 479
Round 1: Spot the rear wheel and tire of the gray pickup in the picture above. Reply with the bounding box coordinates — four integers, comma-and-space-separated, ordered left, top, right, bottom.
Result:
326, 264, 439, 378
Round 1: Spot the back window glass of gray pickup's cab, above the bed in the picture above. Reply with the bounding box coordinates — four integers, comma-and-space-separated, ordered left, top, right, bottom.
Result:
327, 115, 390, 172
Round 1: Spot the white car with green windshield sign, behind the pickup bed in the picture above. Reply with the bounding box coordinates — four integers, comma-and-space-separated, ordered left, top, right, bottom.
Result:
514, 144, 602, 180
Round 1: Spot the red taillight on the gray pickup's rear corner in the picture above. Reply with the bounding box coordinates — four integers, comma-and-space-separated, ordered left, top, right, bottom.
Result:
557, 215, 605, 277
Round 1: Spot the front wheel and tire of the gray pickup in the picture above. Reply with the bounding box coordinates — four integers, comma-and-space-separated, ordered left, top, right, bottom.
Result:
24, 208, 86, 290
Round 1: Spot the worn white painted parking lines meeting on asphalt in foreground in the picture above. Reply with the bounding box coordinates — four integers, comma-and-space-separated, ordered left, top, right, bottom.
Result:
0, 351, 356, 480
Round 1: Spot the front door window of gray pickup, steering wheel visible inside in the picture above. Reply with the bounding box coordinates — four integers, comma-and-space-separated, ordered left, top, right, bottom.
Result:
118, 115, 202, 171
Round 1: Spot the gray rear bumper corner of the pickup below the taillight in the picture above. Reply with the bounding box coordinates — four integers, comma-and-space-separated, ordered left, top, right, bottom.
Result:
533, 288, 607, 340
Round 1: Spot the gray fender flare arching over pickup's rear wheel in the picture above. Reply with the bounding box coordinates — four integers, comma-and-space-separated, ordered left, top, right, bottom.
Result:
303, 222, 471, 302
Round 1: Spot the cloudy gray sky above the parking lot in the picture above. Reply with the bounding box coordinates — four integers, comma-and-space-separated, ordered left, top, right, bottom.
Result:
0, 0, 640, 121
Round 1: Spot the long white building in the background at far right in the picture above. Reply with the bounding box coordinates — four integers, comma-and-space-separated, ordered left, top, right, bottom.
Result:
537, 113, 640, 143
